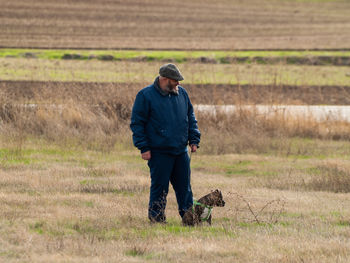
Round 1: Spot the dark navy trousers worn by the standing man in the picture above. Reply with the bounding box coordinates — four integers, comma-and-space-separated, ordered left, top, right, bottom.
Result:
148, 152, 193, 221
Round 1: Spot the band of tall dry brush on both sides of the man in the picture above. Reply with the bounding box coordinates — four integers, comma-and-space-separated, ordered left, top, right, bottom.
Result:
0, 82, 350, 155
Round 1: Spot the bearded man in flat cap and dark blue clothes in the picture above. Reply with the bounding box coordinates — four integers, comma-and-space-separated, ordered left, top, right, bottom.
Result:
130, 64, 200, 223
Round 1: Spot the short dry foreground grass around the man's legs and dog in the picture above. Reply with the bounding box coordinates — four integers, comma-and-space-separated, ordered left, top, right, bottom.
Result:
0, 137, 350, 262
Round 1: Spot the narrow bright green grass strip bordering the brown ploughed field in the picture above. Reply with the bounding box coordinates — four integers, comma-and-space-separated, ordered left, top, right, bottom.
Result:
0, 49, 350, 66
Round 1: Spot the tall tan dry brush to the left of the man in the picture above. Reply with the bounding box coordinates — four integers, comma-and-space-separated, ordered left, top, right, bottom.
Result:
0, 83, 133, 151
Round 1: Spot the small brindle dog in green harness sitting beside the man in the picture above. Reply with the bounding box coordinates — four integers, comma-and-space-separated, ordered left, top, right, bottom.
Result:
182, 189, 225, 226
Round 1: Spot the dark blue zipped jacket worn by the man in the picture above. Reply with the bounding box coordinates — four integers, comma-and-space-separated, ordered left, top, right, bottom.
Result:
130, 77, 201, 154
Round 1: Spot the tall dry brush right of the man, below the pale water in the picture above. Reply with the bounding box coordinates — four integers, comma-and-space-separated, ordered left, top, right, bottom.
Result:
197, 108, 350, 155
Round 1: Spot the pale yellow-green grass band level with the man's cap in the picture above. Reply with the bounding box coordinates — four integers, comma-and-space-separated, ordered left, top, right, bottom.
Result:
0, 58, 350, 86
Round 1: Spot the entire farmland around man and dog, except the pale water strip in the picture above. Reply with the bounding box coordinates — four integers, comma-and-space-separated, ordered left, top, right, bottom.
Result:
0, 0, 350, 263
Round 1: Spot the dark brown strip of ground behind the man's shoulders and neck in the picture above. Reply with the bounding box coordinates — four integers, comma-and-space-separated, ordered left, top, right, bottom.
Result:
0, 80, 350, 105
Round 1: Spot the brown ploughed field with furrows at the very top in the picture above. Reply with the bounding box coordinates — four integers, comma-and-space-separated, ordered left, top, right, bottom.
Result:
0, 0, 350, 50
